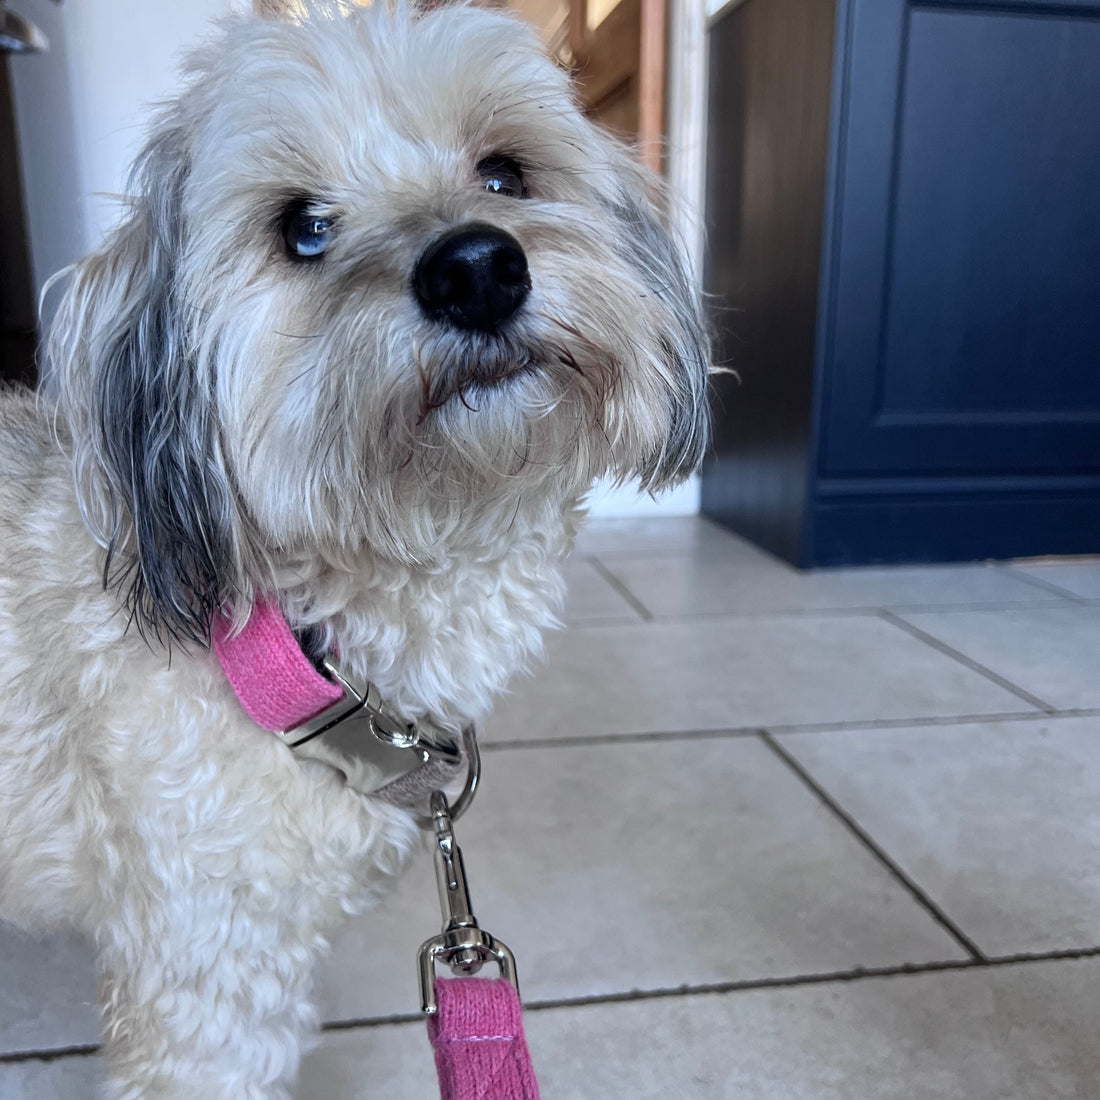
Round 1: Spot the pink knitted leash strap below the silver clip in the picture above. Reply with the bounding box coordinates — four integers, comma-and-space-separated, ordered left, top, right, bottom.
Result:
428, 978, 539, 1100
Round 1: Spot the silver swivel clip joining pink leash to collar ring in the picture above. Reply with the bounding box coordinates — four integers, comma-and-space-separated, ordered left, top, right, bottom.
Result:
417, 792, 519, 1016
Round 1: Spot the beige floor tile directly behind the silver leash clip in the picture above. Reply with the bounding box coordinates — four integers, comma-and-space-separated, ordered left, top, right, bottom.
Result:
323, 738, 964, 1019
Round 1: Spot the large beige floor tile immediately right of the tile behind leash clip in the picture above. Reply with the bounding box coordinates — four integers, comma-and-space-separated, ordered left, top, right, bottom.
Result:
780, 718, 1100, 955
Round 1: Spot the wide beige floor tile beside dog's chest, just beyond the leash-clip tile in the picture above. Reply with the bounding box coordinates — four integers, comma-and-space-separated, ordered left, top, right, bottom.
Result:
485, 615, 1029, 740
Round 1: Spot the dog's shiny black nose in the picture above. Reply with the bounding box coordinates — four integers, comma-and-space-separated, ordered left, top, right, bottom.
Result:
413, 221, 531, 332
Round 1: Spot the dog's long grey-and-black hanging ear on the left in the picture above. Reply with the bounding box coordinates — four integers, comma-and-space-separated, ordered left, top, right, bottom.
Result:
48, 117, 237, 645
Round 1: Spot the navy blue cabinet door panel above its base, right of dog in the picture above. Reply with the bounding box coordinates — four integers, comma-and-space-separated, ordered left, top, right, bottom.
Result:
822, 0, 1100, 475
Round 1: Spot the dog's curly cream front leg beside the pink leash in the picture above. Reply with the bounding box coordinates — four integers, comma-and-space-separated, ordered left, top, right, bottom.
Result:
84, 739, 417, 1100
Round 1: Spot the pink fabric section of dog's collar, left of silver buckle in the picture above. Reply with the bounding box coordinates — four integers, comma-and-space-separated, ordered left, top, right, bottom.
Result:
210, 596, 343, 732
